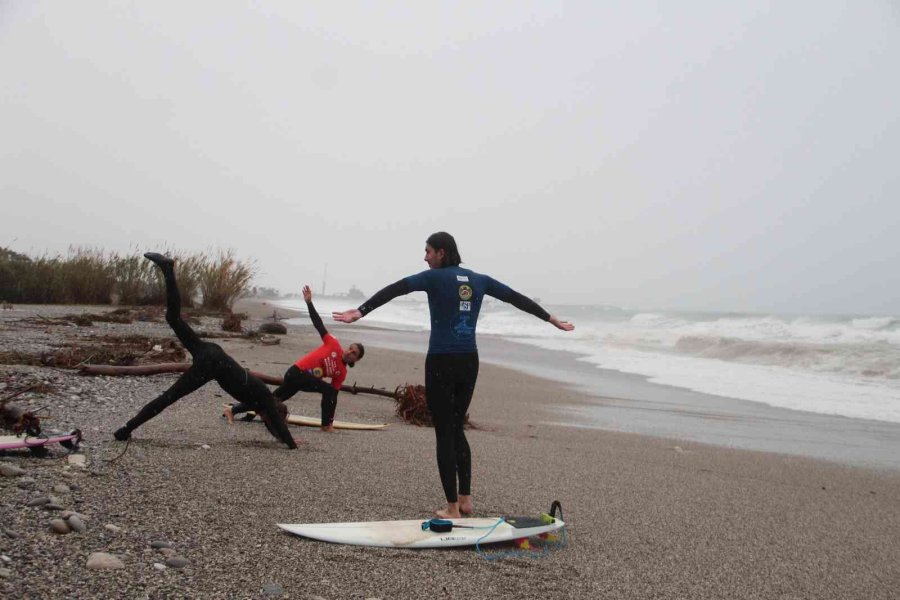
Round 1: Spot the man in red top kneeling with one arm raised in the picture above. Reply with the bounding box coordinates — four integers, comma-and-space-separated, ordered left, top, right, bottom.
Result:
224, 285, 366, 432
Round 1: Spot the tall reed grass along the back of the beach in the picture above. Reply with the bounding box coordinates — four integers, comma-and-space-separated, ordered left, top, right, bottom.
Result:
0, 247, 257, 311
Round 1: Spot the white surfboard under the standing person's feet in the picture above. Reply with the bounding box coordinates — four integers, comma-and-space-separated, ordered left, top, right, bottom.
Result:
278, 515, 565, 548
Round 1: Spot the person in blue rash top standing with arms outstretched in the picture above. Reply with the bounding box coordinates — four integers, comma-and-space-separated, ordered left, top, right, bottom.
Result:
332, 231, 575, 519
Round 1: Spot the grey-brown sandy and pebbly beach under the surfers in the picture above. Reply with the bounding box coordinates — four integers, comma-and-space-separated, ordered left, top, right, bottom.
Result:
0, 303, 900, 599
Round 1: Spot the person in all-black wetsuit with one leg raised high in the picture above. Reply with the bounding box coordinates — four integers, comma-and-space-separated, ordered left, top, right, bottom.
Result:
113, 252, 297, 449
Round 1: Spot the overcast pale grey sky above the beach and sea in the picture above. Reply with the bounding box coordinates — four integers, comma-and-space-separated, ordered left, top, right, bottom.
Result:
0, 0, 900, 316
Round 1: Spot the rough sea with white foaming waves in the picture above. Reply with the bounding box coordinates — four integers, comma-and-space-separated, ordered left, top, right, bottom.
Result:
279, 293, 900, 423
